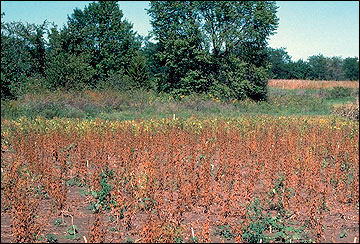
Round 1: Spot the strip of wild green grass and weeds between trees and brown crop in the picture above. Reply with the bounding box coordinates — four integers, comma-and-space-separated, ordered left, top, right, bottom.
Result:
1, 87, 359, 120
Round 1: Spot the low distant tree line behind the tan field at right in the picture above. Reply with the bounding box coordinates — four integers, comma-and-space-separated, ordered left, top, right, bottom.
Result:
268, 47, 359, 80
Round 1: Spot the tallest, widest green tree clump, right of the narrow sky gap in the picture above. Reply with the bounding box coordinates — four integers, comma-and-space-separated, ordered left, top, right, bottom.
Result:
148, 1, 278, 100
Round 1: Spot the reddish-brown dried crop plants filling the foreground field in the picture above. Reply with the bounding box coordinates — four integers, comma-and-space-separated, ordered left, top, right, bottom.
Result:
1, 117, 359, 242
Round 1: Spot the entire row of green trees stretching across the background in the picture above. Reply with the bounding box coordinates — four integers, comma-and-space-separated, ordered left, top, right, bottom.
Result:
1, 1, 358, 100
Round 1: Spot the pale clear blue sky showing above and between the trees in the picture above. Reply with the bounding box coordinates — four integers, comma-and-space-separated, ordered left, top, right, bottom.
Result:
1, 1, 359, 61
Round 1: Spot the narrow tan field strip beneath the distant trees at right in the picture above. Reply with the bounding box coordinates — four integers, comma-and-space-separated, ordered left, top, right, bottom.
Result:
268, 79, 359, 90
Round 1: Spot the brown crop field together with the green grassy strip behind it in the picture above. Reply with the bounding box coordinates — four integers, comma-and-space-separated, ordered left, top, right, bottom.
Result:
1, 79, 359, 243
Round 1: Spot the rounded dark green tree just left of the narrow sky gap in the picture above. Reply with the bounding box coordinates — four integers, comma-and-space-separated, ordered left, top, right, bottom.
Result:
64, 1, 141, 86
